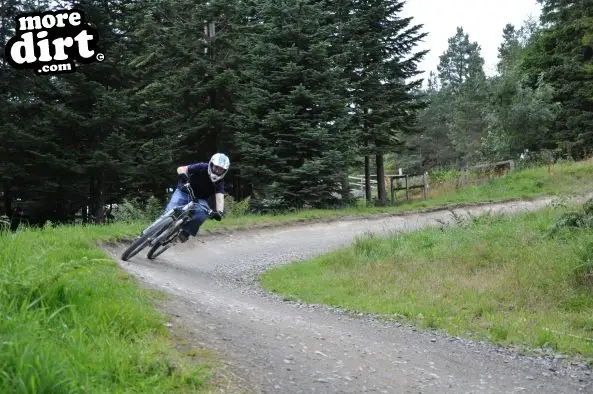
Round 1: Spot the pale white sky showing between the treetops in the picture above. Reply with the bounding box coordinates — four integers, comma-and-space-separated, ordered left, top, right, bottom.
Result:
402, 0, 541, 84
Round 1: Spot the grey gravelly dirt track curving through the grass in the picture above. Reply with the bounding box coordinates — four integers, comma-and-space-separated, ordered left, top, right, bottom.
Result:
108, 199, 593, 393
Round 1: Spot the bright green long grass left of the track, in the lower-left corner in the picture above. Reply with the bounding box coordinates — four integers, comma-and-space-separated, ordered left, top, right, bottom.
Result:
0, 225, 217, 394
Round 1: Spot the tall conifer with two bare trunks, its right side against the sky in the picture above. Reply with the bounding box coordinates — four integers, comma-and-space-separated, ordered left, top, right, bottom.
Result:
348, 0, 427, 203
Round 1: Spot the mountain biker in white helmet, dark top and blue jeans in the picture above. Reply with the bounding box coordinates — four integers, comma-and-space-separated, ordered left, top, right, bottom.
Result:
165, 153, 231, 243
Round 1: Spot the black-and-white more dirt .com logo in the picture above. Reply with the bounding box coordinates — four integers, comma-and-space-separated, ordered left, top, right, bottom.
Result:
4, 9, 105, 75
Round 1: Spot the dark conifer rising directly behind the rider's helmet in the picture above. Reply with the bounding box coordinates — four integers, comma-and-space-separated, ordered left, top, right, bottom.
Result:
132, 0, 248, 195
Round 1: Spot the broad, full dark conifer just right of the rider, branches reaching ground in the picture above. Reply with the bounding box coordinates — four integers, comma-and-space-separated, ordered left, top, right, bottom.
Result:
236, 0, 356, 207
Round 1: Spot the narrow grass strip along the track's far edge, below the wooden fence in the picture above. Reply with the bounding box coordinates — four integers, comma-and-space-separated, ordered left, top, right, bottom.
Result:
202, 160, 593, 230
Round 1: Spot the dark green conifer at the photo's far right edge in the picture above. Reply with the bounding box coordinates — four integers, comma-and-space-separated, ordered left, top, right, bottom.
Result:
523, 0, 593, 158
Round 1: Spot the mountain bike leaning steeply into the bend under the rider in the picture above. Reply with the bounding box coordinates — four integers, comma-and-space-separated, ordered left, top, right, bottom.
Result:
121, 174, 215, 261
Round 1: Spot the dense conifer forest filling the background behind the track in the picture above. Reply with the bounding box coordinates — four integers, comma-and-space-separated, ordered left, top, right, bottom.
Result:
0, 0, 593, 225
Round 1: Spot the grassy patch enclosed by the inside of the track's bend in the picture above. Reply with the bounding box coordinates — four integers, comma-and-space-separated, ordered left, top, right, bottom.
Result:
260, 208, 593, 360
